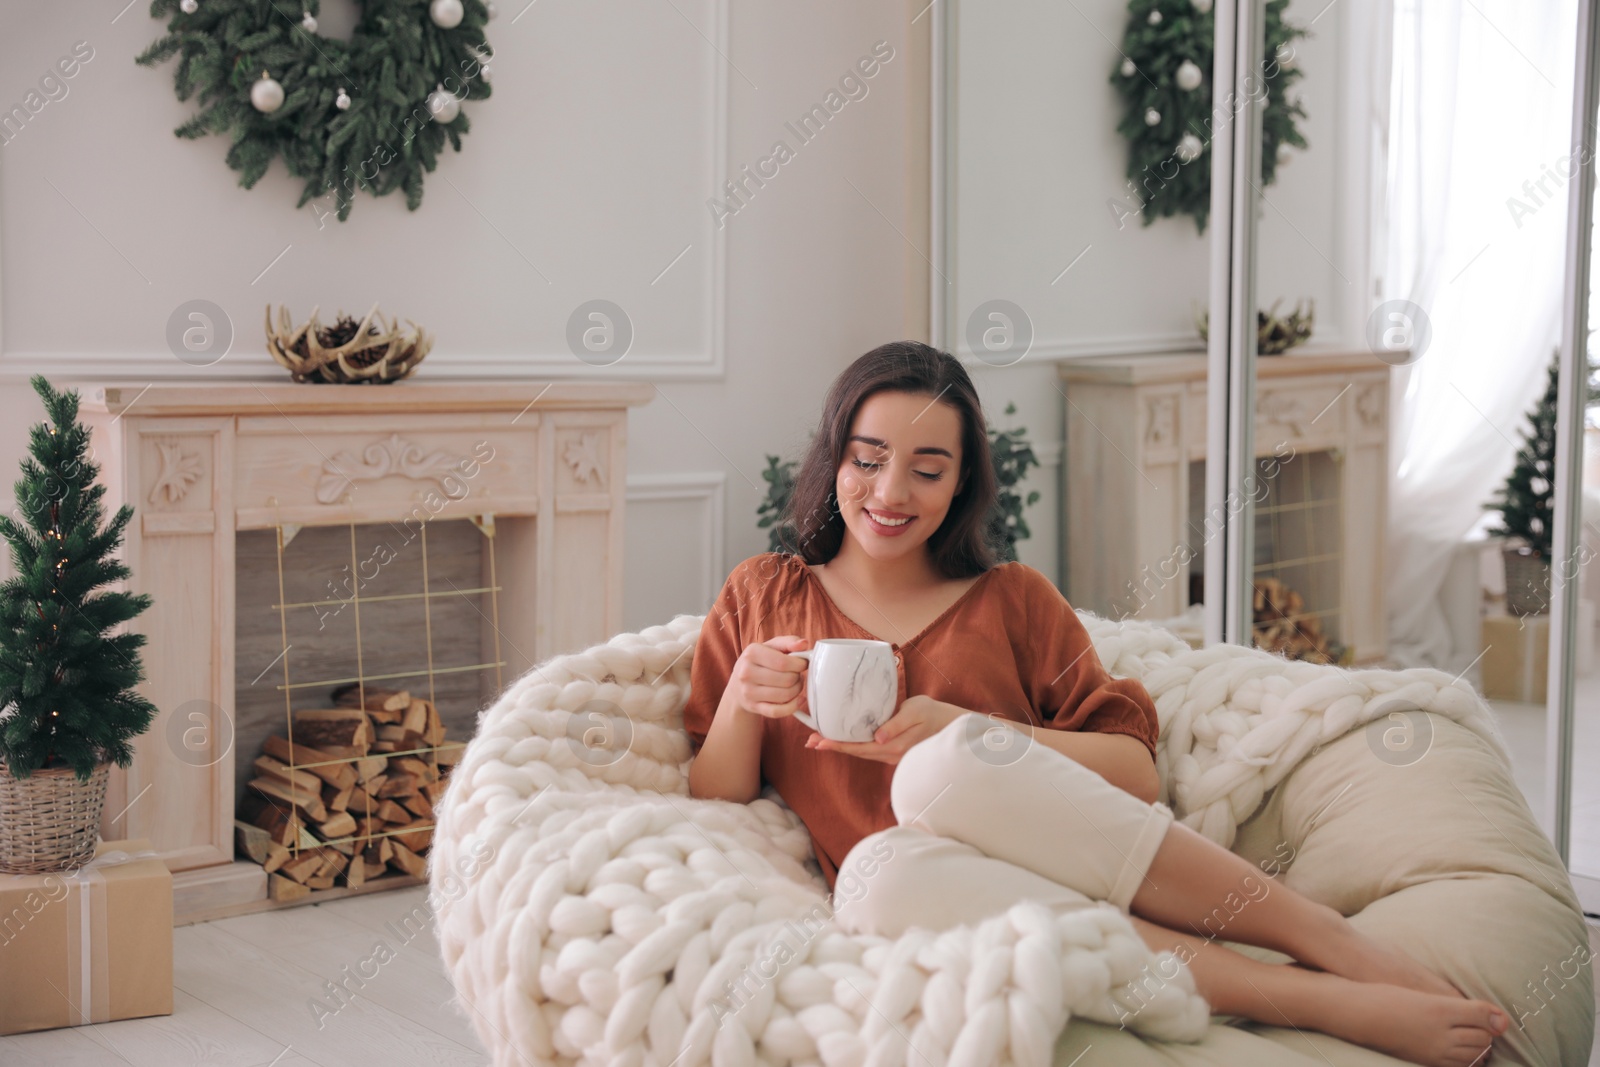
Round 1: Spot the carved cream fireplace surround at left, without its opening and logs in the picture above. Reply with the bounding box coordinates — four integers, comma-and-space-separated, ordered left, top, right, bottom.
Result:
72, 379, 654, 921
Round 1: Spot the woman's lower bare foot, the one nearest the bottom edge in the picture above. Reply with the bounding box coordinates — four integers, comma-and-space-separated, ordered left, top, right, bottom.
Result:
1310, 976, 1510, 1067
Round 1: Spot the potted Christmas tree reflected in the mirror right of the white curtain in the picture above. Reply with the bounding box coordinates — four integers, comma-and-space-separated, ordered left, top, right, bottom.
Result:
1485, 349, 1600, 616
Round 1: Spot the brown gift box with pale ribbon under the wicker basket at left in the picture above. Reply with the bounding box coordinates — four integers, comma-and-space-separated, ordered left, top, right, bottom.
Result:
0, 840, 173, 1033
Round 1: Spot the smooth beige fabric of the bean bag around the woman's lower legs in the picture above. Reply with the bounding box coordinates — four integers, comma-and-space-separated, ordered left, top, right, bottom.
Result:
1054, 715, 1595, 1067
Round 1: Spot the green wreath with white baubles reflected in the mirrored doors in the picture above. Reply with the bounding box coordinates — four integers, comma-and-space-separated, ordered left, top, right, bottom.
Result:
1110, 0, 1306, 234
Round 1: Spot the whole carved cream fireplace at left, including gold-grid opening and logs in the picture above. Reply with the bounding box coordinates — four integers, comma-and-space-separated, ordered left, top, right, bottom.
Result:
74, 379, 654, 921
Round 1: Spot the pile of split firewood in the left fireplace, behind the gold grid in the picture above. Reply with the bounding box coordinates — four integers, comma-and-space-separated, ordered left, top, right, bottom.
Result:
234, 685, 466, 901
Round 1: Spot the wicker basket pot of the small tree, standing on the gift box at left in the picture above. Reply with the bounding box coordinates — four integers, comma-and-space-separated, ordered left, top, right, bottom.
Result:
0, 763, 110, 875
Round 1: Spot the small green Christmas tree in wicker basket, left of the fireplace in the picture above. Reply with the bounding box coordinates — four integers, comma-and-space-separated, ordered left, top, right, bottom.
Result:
0, 374, 155, 873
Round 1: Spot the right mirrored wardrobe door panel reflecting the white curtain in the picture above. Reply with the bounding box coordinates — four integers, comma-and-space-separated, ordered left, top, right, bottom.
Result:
1251, 0, 1580, 857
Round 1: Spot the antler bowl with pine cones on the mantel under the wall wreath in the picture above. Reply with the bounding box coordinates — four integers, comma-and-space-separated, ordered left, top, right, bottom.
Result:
267, 304, 434, 382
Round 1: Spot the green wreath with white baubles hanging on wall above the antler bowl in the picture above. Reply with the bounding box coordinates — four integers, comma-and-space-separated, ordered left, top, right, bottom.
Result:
136, 0, 493, 222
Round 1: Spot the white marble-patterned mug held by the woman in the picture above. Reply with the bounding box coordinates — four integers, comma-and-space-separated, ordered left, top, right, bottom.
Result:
789, 637, 899, 741
